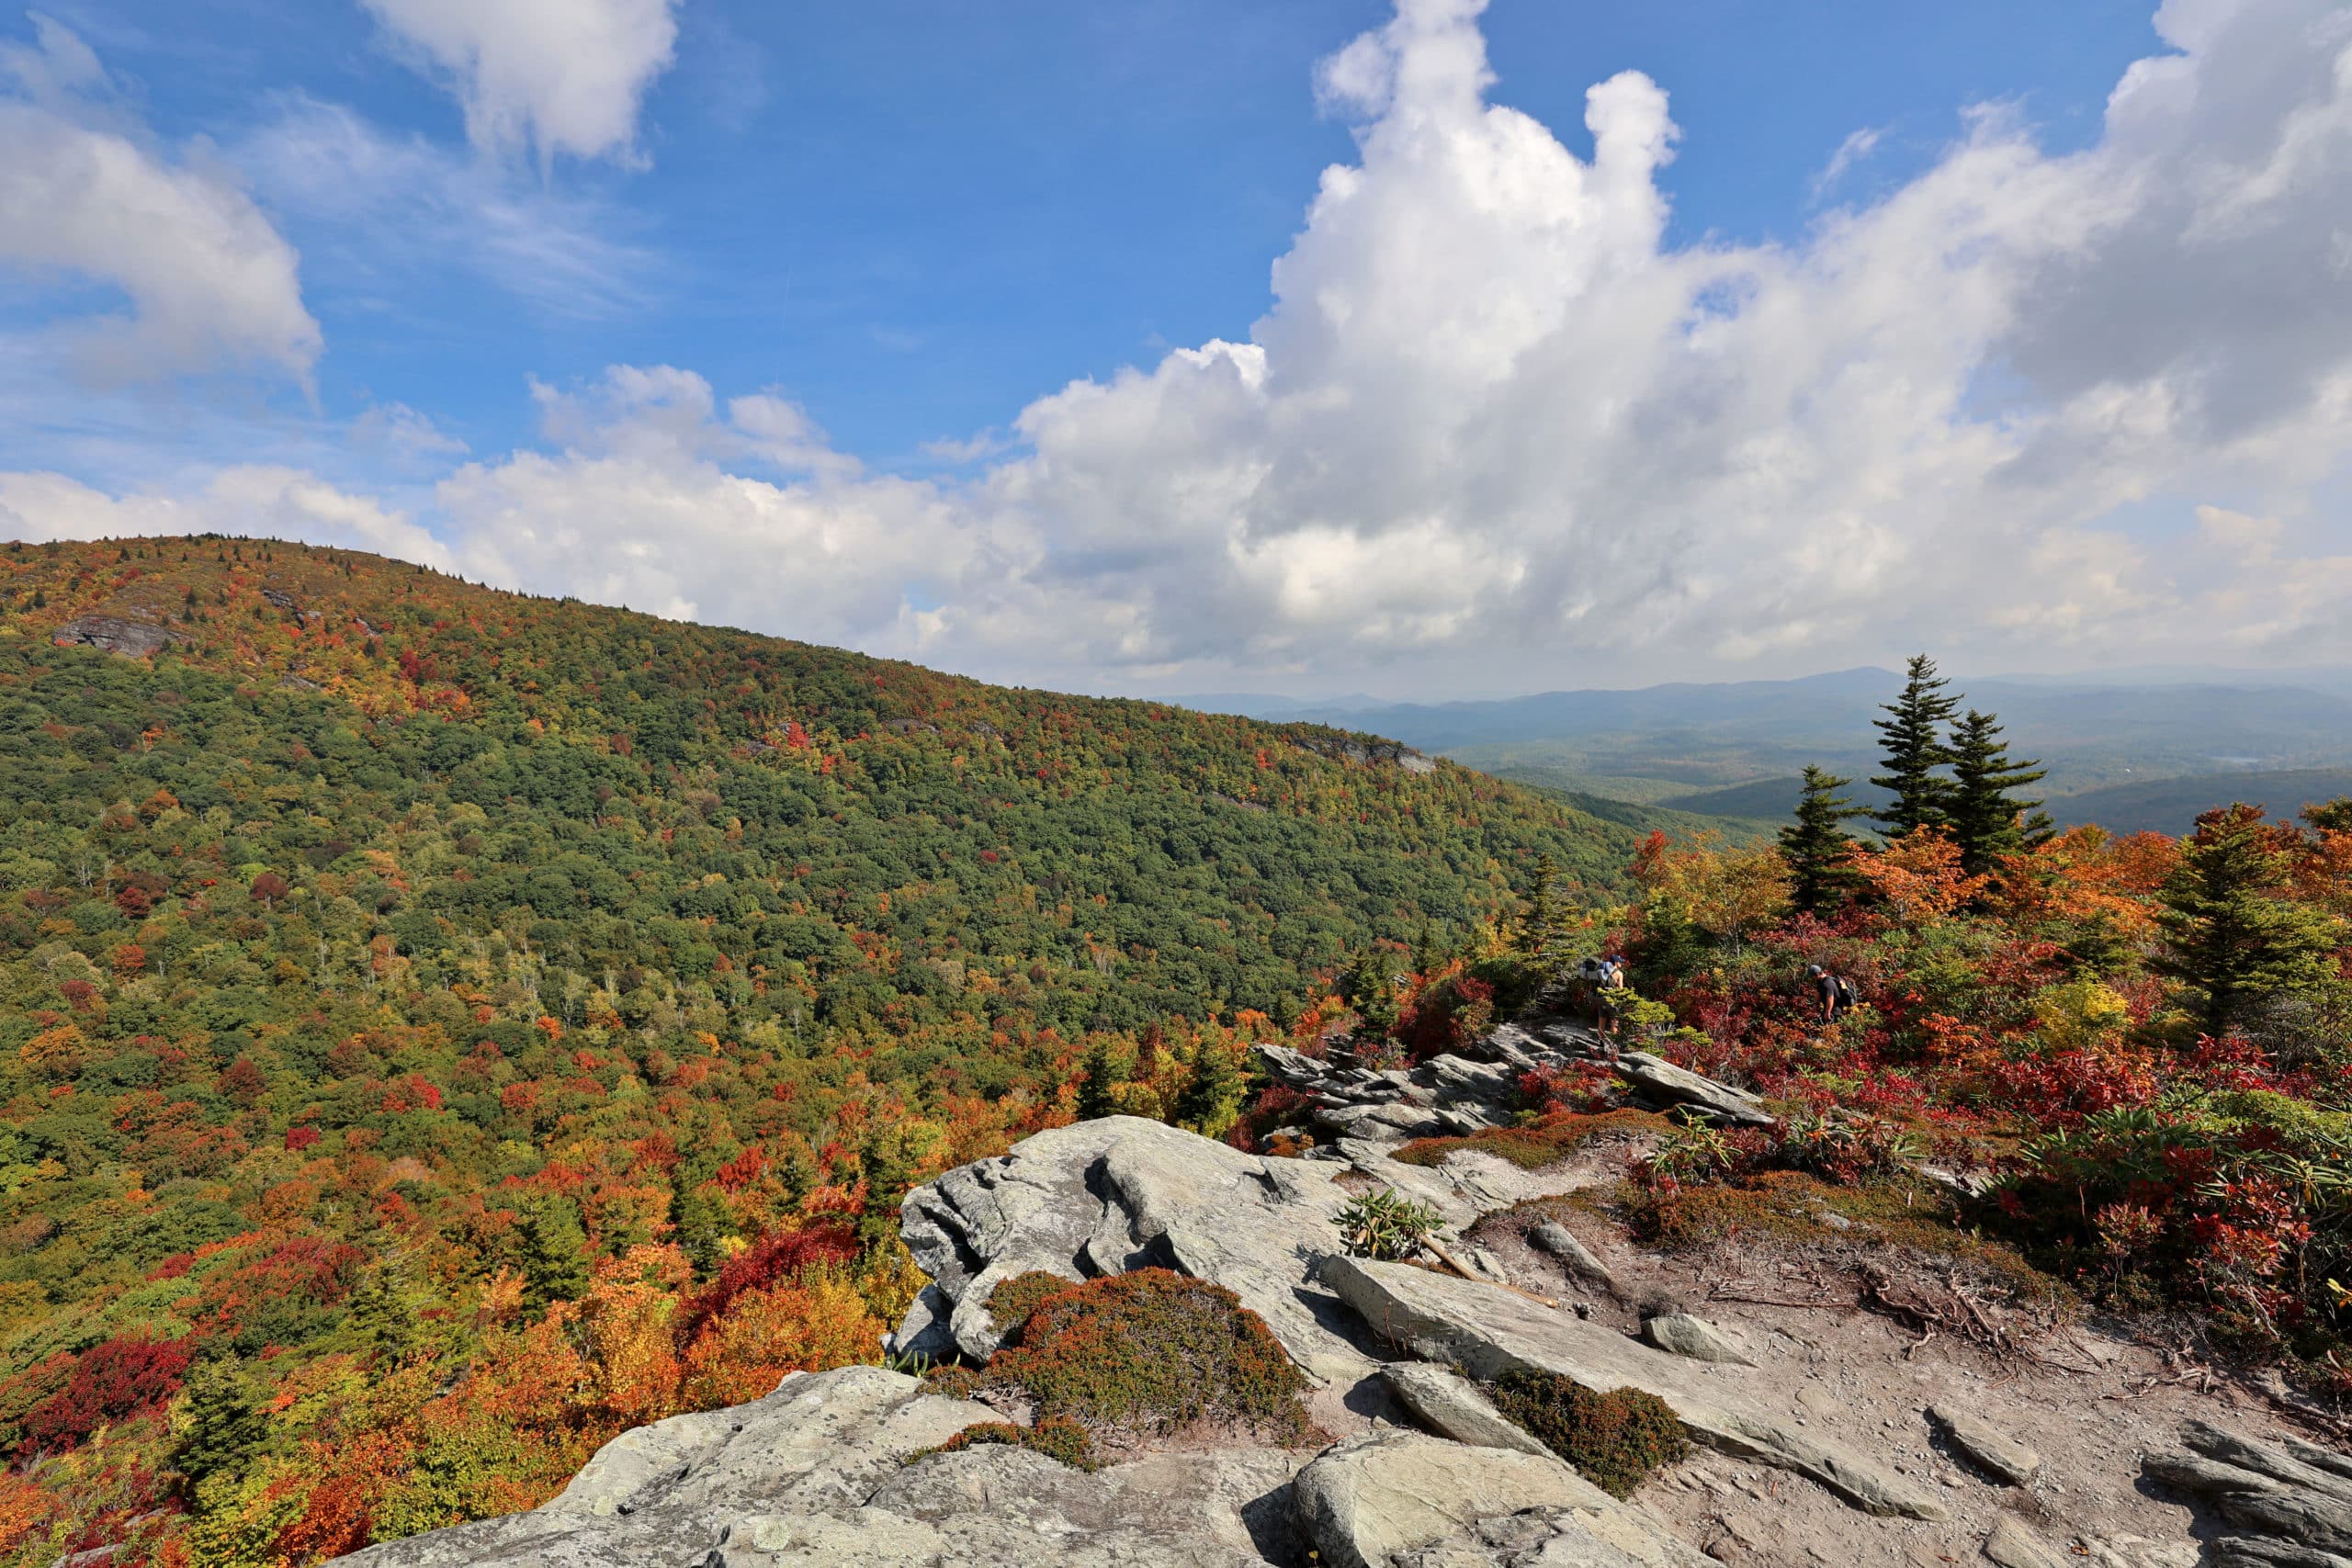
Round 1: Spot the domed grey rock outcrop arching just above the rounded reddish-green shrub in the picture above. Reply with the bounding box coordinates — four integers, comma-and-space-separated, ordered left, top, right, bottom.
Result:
894, 1117, 1371, 1382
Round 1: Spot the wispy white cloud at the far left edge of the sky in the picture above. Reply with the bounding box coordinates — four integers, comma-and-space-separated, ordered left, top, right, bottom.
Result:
0, 17, 322, 383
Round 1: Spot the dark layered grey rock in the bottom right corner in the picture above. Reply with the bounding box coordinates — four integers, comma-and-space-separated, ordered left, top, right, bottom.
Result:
2145, 1422, 2352, 1568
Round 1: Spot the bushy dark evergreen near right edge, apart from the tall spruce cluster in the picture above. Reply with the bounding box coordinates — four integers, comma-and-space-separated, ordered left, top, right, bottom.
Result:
2157, 804, 2340, 1037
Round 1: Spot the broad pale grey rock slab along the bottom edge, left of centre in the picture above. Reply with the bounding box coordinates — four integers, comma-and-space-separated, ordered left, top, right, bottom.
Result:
341, 1366, 1307, 1568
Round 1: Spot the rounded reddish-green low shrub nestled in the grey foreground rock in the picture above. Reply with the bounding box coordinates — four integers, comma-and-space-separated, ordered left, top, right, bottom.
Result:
986, 1269, 1312, 1443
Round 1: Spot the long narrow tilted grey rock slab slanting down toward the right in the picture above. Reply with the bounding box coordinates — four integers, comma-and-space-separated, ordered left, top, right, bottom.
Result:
1322, 1258, 1945, 1518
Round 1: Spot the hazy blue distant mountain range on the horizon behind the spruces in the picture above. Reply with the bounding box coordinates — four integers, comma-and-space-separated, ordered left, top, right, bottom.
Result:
1188, 668, 2352, 832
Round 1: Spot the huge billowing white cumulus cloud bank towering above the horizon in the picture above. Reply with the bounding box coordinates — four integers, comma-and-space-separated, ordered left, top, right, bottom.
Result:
14, 0, 2352, 691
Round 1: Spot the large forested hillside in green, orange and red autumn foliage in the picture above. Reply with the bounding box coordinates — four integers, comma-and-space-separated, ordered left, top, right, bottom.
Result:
0, 538, 1637, 1565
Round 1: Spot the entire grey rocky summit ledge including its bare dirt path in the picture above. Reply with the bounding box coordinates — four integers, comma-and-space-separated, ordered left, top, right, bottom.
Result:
345, 1021, 2352, 1568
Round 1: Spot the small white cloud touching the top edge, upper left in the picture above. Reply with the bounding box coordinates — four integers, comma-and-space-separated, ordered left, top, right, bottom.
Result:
362, 0, 680, 167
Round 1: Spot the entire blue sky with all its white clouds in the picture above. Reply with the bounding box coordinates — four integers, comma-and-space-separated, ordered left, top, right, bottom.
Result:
0, 0, 2352, 696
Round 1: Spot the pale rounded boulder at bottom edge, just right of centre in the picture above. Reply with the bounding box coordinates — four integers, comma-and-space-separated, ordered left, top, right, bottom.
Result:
1291, 1427, 1713, 1568
